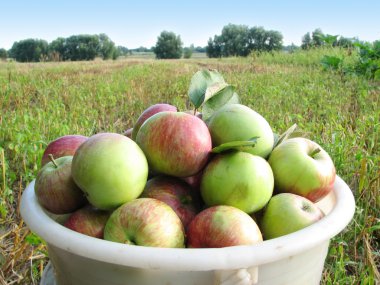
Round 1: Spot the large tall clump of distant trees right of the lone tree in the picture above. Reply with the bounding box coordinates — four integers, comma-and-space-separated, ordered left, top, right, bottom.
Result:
206, 24, 283, 57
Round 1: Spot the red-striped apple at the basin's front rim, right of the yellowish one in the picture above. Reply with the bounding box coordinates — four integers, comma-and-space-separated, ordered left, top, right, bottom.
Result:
186, 205, 263, 248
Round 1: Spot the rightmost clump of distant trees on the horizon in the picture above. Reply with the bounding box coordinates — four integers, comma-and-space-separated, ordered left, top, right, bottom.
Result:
301, 29, 359, 49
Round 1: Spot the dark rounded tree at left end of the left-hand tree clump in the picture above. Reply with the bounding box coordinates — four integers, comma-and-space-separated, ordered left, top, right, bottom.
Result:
10, 39, 49, 62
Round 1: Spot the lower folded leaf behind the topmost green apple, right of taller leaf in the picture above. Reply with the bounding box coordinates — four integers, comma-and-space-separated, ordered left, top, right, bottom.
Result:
202, 84, 239, 122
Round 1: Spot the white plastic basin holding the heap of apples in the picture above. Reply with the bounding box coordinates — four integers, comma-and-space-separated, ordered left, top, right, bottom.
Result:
21, 177, 355, 285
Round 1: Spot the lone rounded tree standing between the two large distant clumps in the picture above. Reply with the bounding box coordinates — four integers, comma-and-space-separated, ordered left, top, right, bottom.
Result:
153, 31, 183, 59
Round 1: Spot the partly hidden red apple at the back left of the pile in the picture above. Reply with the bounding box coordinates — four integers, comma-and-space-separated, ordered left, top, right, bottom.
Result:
41, 135, 88, 166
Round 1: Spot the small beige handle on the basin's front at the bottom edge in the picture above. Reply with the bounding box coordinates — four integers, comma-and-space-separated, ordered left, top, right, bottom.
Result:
214, 267, 259, 285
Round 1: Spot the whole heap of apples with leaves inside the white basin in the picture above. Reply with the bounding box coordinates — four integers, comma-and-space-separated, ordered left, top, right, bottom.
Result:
35, 70, 335, 248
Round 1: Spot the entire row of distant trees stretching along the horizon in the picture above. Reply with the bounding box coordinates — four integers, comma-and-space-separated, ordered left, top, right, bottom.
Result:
0, 24, 372, 62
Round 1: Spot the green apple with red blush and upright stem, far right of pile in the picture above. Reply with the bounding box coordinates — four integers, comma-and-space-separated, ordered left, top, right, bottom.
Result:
268, 138, 336, 202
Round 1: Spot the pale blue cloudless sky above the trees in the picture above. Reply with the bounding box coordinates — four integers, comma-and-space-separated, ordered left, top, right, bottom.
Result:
0, 0, 380, 49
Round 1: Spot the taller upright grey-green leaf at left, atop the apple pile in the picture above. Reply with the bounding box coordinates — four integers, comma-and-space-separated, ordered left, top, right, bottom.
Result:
188, 69, 225, 109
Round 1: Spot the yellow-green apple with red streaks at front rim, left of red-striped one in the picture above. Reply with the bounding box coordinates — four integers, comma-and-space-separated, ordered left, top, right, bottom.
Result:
104, 198, 185, 248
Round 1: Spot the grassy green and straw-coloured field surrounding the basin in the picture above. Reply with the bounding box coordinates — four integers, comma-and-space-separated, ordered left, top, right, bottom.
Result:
0, 50, 380, 285
